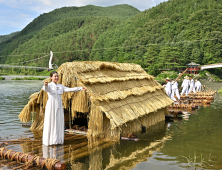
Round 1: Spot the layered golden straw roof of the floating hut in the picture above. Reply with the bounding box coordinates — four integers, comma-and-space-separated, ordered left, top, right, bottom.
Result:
18, 61, 173, 129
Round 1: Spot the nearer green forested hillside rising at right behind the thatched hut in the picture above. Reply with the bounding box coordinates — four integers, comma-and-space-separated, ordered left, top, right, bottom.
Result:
90, 0, 222, 75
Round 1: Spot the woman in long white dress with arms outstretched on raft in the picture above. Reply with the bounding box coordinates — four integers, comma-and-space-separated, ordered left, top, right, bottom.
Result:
42, 71, 87, 146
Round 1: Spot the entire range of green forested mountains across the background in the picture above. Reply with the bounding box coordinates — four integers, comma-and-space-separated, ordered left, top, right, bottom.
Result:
0, 0, 222, 74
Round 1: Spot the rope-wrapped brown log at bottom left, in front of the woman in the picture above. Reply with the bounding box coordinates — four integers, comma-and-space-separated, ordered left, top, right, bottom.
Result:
0, 148, 66, 170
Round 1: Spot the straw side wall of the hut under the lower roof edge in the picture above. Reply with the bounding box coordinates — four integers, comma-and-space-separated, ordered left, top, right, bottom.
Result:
103, 109, 165, 140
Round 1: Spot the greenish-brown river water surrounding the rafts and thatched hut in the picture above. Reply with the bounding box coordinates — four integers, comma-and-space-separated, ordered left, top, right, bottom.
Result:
0, 80, 222, 170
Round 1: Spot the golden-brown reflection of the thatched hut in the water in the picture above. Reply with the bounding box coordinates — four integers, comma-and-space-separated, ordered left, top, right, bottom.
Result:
63, 121, 172, 170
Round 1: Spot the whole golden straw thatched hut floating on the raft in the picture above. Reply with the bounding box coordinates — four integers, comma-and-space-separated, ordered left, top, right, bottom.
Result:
19, 61, 173, 140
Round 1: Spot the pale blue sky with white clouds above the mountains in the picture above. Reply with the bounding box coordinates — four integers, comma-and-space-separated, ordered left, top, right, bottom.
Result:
0, 0, 167, 35
